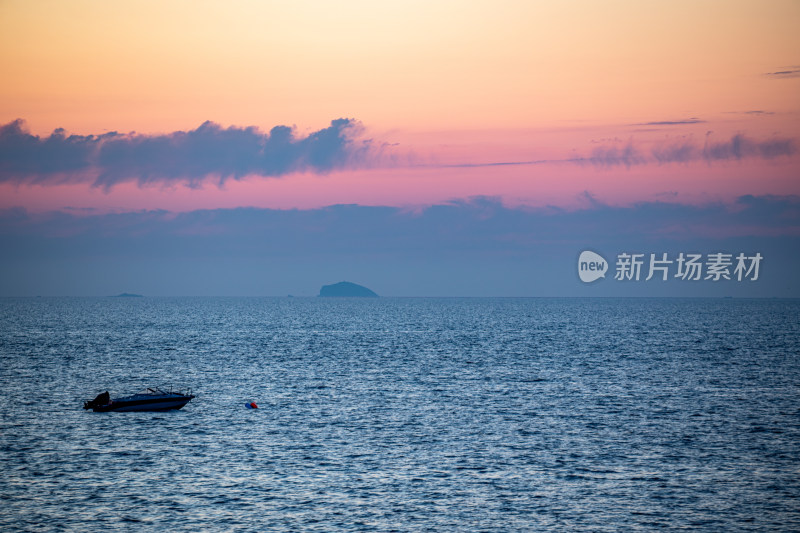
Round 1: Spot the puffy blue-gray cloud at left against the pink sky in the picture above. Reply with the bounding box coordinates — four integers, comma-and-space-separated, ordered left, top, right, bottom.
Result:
0, 118, 372, 188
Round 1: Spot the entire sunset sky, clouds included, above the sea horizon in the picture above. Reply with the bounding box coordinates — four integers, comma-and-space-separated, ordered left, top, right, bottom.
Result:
0, 0, 800, 297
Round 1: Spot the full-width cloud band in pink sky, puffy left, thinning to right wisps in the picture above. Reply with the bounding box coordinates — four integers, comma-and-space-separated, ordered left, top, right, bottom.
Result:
0, 119, 797, 185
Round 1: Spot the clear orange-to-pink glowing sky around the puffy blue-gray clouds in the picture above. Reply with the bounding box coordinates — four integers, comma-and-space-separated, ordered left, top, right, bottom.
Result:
0, 0, 800, 209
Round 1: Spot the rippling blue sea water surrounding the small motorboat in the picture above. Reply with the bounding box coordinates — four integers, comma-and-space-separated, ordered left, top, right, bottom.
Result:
0, 298, 800, 531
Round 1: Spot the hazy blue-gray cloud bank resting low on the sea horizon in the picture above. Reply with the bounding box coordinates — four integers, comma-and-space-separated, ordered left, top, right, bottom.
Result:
0, 194, 800, 296
